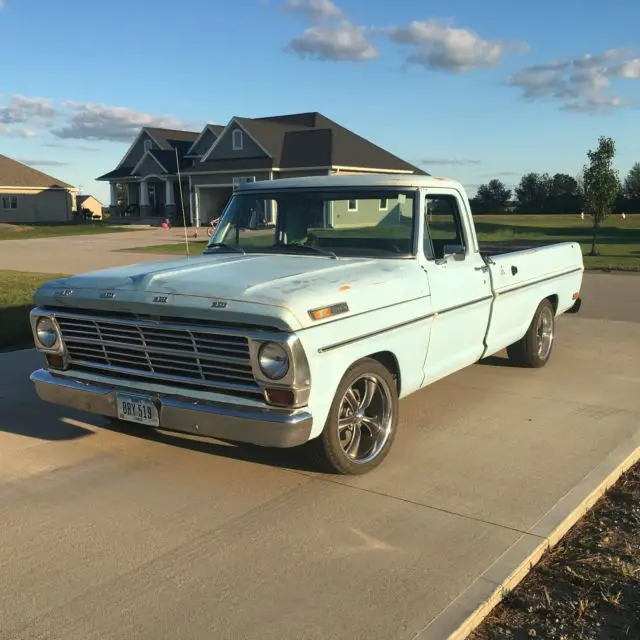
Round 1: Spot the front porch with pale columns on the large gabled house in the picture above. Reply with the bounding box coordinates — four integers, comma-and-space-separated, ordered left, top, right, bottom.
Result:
109, 177, 191, 225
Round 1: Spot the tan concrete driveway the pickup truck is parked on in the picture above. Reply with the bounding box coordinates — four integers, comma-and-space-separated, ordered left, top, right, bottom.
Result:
0, 280, 640, 640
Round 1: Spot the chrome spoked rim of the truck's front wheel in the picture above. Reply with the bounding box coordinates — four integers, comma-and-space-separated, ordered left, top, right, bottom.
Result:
338, 373, 393, 464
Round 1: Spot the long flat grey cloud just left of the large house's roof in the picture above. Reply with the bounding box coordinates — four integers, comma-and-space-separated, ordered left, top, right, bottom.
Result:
51, 100, 187, 142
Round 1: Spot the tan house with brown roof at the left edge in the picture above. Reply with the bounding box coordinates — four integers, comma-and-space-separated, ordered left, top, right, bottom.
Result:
0, 154, 78, 224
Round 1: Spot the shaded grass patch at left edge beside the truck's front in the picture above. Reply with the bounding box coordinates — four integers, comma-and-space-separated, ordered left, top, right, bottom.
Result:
0, 270, 66, 349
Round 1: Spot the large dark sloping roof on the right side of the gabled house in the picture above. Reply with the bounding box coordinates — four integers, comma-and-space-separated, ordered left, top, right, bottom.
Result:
188, 112, 425, 175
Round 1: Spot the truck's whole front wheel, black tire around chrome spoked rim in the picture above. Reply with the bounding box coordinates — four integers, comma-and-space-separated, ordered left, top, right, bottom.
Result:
309, 358, 399, 475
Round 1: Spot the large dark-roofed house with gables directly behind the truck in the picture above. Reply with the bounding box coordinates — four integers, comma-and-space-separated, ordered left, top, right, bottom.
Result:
97, 112, 424, 226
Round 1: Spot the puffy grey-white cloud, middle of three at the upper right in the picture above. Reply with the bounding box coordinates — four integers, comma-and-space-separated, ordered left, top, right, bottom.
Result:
383, 20, 526, 73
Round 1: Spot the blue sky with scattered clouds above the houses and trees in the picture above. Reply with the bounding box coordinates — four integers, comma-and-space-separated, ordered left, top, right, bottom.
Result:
0, 0, 640, 204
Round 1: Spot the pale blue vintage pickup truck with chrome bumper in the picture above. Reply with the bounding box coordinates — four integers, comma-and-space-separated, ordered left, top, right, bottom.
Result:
31, 174, 584, 474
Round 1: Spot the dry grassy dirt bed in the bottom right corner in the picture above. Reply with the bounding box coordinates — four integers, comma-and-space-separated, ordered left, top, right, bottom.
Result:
468, 463, 640, 640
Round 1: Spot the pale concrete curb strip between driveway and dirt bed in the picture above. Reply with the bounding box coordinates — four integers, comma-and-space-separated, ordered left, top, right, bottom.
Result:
414, 430, 640, 640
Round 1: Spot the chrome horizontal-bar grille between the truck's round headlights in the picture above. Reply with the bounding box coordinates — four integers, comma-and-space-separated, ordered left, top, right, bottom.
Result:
56, 315, 259, 394
